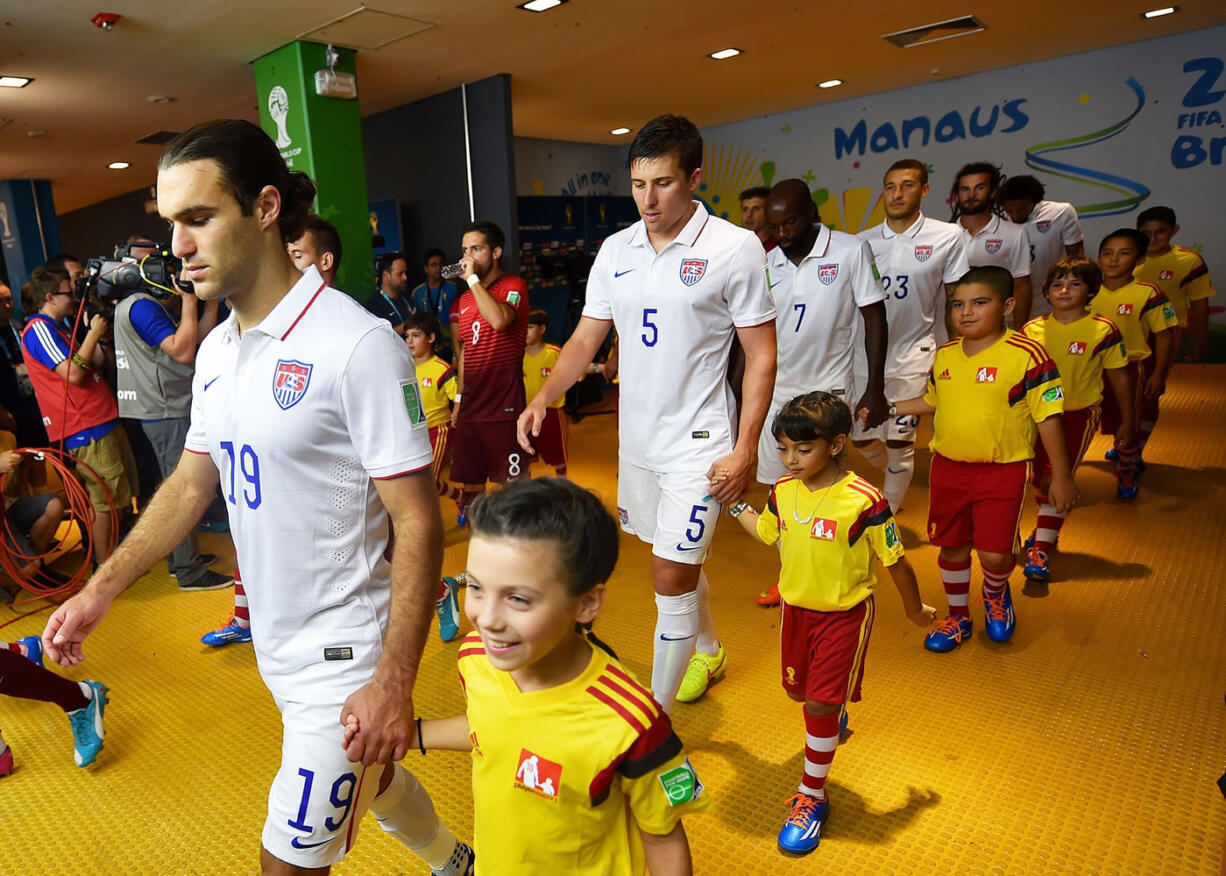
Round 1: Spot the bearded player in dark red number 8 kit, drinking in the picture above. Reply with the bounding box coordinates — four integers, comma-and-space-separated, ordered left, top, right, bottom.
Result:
451, 222, 528, 526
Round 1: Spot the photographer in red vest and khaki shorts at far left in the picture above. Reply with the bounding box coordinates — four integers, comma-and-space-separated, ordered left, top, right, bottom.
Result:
21, 268, 136, 562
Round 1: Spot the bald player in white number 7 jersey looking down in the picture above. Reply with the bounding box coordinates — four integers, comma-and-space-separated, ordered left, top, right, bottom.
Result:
758, 179, 889, 605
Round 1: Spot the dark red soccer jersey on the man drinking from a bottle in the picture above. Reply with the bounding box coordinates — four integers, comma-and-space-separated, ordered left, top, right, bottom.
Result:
452, 273, 528, 421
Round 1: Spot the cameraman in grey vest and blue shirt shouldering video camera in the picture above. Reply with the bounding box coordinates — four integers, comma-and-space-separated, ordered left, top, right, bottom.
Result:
115, 238, 233, 591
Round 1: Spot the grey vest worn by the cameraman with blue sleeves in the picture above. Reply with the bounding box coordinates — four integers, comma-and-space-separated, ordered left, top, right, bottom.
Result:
115, 292, 196, 420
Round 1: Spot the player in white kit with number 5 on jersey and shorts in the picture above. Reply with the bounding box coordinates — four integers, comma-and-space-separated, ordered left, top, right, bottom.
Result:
519, 115, 775, 709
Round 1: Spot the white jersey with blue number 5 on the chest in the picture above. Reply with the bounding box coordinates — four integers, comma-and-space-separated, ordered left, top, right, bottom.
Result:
584, 201, 775, 472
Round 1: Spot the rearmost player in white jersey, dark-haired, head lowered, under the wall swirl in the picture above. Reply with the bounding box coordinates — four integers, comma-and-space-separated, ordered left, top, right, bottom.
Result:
1000, 175, 1085, 318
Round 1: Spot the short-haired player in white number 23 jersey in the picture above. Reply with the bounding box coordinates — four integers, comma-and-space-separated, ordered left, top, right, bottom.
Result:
852, 158, 970, 513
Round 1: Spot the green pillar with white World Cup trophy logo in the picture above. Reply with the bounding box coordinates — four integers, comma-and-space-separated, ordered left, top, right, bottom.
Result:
254, 42, 374, 301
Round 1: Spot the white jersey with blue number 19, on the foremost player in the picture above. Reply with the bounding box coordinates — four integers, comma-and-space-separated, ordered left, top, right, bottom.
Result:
186, 267, 430, 702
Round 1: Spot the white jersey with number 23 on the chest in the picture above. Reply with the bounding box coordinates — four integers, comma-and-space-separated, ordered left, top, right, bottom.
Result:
856, 213, 970, 379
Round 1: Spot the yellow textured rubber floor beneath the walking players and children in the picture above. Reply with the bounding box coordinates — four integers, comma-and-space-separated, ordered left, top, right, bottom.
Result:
0, 365, 1226, 876
